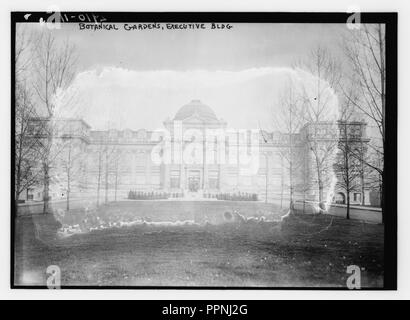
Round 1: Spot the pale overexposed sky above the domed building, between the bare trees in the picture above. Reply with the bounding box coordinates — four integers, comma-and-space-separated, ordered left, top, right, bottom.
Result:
24, 23, 346, 130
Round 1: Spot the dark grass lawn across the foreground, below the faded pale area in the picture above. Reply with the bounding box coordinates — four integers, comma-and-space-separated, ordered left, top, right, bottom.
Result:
15, 203, 383, 287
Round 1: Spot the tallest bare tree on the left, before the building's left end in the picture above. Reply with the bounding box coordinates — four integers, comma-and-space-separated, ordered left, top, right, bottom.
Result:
32, 30, 75, 214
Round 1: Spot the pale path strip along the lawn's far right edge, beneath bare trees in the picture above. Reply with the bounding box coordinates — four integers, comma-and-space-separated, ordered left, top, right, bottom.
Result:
295, 201, 382, 223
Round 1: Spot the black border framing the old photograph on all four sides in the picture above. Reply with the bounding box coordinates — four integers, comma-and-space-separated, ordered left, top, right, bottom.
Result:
10, 11, 398, 291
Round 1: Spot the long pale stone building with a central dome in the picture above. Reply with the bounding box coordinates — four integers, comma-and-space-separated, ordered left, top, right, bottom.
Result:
24, 100, 378, 203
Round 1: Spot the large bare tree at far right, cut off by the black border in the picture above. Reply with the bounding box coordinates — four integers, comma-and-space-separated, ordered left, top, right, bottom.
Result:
343, 24, 386, 221
